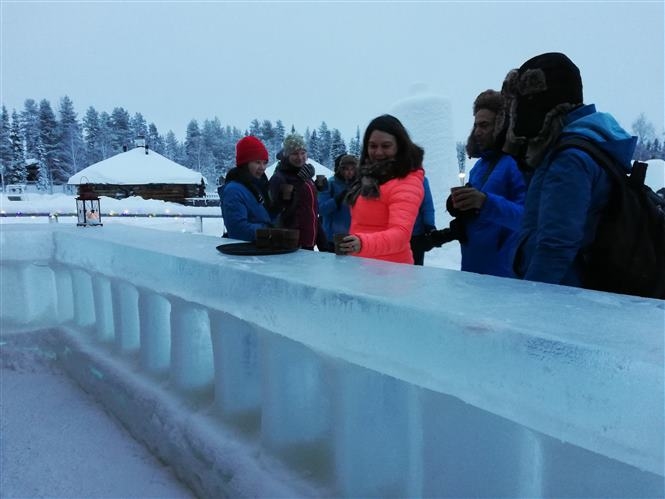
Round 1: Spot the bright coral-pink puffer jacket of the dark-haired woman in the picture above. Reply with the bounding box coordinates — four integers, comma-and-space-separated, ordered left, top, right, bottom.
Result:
349, 169, 425, 264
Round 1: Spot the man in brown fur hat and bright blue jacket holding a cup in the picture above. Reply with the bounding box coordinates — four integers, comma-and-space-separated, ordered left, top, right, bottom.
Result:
440, 90, 526, 277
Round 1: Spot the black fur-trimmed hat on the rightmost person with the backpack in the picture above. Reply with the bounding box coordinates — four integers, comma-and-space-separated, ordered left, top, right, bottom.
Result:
514, 52, 584, 137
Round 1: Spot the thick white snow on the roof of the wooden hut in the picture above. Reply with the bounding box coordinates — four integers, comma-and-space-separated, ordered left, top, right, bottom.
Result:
67, 147, 207, 185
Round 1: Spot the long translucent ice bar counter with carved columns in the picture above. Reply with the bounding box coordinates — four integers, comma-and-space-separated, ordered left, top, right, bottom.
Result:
0, 225, 665, 497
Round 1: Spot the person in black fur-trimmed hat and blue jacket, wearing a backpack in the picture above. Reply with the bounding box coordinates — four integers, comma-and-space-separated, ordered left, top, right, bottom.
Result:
504, 53, 637, 287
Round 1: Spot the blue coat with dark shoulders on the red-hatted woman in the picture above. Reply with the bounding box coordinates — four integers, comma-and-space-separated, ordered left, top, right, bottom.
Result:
219, 168, 273, 241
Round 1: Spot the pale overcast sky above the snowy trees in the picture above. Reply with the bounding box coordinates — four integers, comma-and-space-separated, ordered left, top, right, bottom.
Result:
0, 0, 665, 145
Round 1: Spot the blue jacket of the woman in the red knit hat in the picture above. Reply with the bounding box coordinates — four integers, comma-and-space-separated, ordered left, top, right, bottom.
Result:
220, 175, 272, 241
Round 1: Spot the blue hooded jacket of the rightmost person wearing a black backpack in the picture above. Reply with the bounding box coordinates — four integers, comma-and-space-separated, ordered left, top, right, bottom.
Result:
514, 105, 637, 286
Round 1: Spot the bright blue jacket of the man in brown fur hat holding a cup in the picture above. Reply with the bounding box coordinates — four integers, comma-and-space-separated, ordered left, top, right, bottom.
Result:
461, 151, 526, 277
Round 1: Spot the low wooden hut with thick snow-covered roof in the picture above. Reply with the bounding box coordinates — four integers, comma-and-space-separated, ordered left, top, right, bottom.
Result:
67, 146, 207, 204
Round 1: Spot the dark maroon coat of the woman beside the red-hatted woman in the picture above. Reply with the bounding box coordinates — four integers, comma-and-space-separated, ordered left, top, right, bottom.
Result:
270, 159, 325, 249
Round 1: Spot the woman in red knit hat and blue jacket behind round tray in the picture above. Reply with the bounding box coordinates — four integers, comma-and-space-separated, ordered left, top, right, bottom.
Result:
219, 135, 273, 241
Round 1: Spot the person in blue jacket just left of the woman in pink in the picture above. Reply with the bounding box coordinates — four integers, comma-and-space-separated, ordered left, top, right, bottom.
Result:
318, 154, 358, 251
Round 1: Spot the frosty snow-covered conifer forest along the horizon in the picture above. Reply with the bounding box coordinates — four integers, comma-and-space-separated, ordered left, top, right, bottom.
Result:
0, 96, 665, 192
